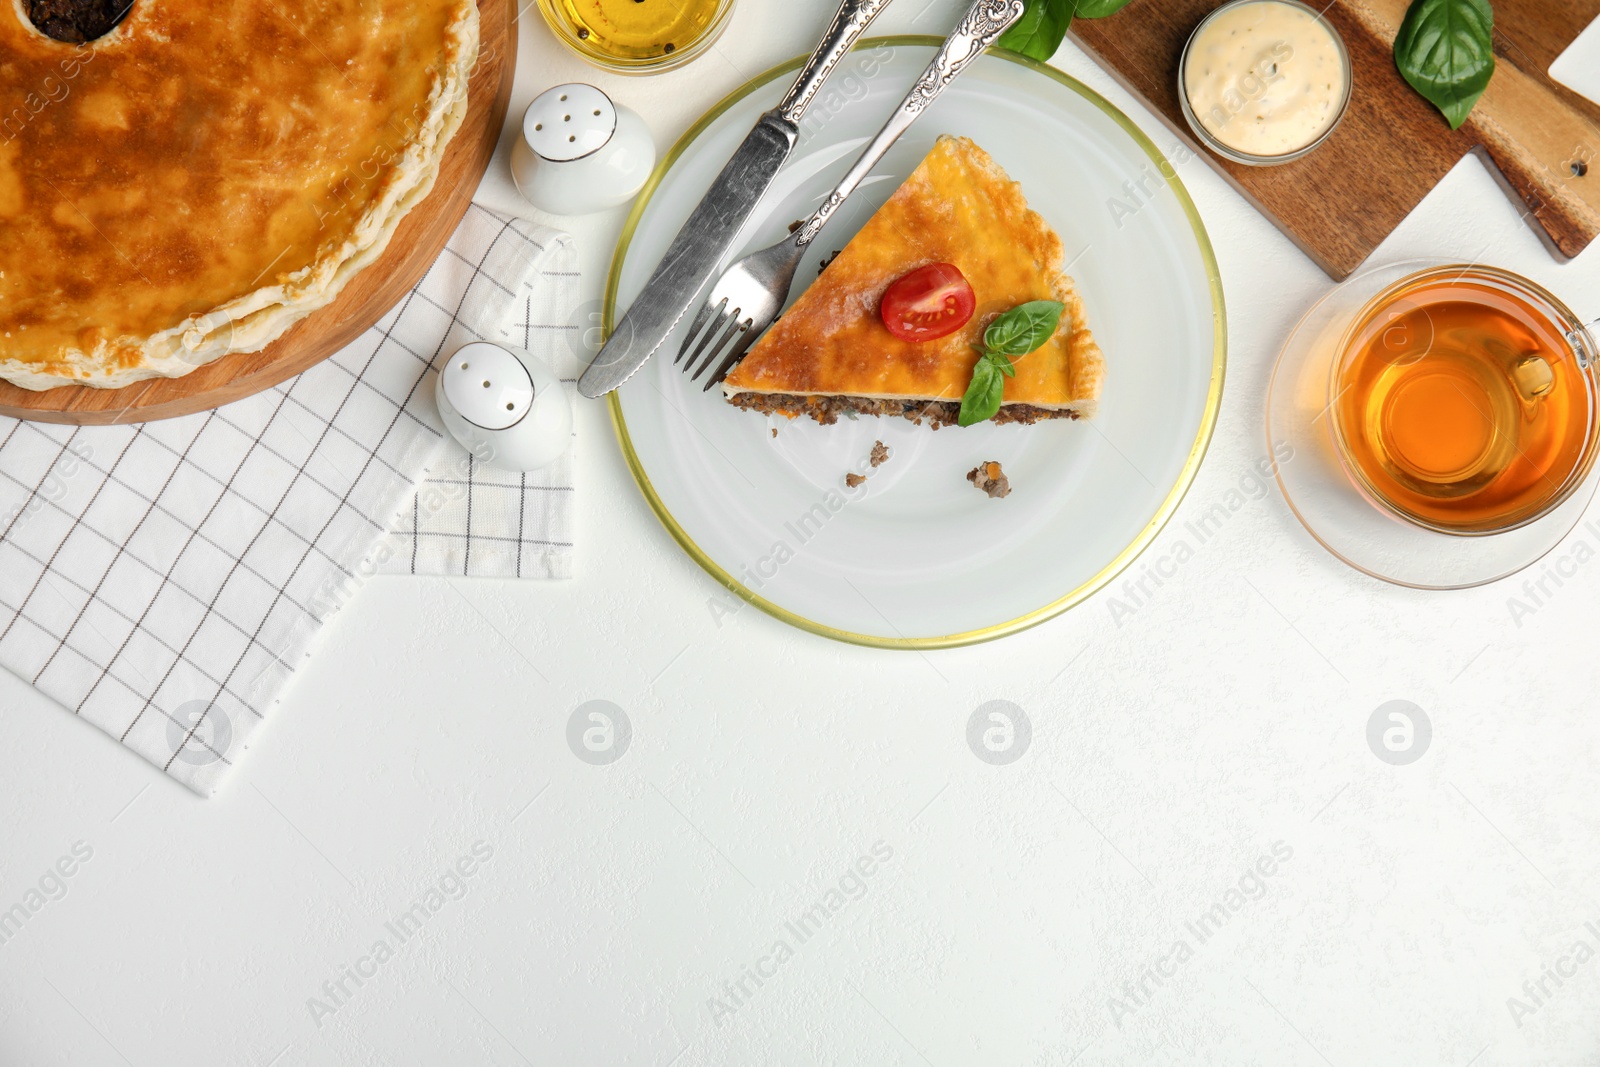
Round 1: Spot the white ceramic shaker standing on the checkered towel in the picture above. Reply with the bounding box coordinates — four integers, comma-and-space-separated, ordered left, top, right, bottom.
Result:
434, 341, 573, 472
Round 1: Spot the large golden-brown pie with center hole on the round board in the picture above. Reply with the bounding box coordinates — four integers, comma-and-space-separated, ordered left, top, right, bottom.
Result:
0, 0, 478, 389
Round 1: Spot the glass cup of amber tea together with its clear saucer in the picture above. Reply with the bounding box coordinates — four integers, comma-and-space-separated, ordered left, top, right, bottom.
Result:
1267, 261, 1600, 589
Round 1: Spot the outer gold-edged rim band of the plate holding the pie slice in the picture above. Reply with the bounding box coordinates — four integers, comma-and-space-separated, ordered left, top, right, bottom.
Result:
602, 34, 1227, 651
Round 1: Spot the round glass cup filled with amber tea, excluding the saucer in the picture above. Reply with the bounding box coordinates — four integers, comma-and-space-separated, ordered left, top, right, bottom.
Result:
1333, 267, 1595, 533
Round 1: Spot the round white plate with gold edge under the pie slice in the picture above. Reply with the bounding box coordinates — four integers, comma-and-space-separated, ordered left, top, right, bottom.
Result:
606, 37, 1226, 648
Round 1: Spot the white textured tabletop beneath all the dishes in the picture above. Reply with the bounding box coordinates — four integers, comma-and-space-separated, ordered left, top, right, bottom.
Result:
0, 0, 1600, 1067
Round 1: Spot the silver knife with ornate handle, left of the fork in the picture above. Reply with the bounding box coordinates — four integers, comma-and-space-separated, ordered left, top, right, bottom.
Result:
578, 0, 890, 398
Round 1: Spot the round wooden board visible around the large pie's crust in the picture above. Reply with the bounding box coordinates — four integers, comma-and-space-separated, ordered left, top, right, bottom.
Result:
0, 0, 517, 426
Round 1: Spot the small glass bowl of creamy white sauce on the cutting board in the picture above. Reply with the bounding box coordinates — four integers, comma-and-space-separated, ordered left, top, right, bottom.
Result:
1184, 0, 1350, 157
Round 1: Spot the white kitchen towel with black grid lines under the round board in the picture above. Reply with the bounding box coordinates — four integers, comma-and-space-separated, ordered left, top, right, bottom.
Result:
0, 206, 586, 795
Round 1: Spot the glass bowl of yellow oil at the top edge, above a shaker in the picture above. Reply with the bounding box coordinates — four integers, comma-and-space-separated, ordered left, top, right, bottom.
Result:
538, 0, 734, 74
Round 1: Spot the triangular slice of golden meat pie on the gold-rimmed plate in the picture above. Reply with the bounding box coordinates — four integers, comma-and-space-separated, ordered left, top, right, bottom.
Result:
723, 136, 1106, 429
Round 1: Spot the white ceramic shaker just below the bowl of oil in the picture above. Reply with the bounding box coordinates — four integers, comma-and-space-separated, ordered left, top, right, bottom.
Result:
510, 82, 656, 214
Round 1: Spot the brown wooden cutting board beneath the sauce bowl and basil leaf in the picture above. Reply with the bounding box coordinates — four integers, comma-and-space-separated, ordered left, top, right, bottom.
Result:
1072, 0, 1600, 278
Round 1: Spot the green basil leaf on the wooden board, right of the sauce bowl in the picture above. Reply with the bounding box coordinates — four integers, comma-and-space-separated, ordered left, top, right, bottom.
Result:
1395, 0, 1494, 130
